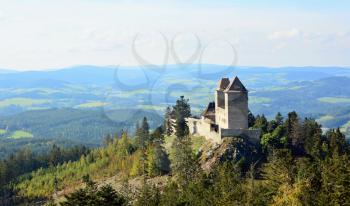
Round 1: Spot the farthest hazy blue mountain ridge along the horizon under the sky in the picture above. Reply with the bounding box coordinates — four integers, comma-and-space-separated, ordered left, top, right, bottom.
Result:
0, 65, 350, 87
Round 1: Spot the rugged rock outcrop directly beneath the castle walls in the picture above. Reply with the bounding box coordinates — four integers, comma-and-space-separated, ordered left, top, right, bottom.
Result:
198, 137, 260, 172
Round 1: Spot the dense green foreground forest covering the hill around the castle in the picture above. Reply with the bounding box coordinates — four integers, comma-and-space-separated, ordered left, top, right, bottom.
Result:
0, 97, 350, 205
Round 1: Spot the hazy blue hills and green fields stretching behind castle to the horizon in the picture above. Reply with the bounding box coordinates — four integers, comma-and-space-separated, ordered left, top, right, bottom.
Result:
0, 65, 350, 140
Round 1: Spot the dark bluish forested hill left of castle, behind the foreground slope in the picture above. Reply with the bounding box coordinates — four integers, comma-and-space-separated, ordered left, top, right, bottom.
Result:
0, 108, 162, 159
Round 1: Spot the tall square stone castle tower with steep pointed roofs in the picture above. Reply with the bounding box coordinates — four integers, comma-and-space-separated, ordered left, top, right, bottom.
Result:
215, 77, 248, 129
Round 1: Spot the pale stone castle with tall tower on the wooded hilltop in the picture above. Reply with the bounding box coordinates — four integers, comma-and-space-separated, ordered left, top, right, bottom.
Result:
187, 77, 260, 143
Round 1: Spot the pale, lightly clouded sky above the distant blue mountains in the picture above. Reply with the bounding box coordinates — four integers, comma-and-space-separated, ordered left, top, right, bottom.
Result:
0, 0, 350, 70
